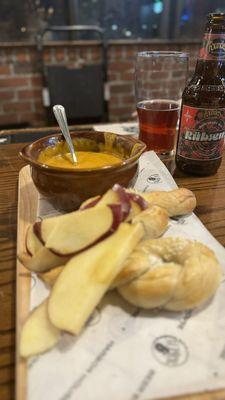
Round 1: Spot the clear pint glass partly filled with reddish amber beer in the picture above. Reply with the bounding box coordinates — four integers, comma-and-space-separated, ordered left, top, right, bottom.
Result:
135, 51, 188, 156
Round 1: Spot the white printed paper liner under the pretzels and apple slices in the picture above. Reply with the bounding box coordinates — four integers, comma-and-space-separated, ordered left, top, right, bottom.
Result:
27, 152, 225, 400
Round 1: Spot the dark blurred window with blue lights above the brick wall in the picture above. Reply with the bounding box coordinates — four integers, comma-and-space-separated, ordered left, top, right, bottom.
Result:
0, 0, 225, 41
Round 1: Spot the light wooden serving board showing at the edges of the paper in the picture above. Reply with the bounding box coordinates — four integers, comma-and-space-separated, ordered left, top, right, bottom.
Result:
15, 166, 225, 400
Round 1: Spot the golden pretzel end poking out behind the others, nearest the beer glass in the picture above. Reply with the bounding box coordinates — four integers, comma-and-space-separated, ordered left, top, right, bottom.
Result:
141, 188, 196, 217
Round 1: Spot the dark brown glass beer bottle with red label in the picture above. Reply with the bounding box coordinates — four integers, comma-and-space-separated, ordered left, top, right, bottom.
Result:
176, 14, 225, 176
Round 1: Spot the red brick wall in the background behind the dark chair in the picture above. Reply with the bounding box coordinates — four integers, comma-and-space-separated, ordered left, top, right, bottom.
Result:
0, 41, 199, 127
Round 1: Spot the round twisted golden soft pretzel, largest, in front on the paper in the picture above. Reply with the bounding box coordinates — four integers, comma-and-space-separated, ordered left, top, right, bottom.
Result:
118, 237, 222, 311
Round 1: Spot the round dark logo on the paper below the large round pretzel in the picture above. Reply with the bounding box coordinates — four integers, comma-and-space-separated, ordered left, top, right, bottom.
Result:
152, 335, 188, 367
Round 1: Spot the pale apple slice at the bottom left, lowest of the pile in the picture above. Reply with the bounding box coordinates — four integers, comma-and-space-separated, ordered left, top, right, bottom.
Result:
20, 300, 60, 357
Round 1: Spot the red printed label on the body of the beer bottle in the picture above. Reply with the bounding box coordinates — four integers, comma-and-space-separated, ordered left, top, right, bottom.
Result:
177, 105, 225, 161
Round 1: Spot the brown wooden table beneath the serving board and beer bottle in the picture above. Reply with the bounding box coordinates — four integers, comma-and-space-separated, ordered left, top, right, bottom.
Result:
0, 129, 225, 400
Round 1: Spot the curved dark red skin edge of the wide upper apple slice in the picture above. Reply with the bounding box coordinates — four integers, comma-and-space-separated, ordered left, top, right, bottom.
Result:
49, 204, 123, 257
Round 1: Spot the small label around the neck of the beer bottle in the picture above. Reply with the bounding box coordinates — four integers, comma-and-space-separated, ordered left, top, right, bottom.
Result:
199, 33, 225, 60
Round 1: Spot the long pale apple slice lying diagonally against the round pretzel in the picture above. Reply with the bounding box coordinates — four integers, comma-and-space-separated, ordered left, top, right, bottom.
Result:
48, 223, 144, 334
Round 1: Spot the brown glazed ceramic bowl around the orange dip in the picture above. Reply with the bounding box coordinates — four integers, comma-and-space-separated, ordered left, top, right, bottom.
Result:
20, 131, 146, 211
